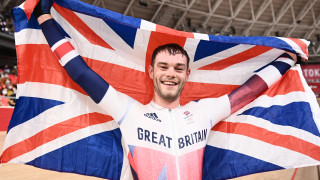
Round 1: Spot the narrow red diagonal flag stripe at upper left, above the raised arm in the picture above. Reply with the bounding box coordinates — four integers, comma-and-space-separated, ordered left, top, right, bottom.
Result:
53, 4, 114, 50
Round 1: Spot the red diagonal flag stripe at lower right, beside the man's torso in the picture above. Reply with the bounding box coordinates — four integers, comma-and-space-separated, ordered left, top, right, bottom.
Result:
212, 121, 320, 161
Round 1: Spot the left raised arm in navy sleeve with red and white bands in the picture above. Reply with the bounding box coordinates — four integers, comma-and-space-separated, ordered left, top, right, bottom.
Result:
33, 0, 109, 103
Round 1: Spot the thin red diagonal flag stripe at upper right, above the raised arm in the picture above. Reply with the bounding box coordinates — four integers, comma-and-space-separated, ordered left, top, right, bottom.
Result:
199, 46, 272, 70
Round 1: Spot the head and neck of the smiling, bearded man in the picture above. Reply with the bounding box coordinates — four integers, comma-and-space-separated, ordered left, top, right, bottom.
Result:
149, 44, 190, 108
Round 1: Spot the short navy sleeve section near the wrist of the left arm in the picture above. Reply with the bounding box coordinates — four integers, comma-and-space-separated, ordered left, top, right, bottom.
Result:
40, 19, 64, 47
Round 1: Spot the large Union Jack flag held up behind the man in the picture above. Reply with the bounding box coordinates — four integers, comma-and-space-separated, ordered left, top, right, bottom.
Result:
1, 0, 320, 179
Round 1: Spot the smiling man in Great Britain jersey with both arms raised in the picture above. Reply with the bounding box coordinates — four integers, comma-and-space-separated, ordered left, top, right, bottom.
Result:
34, 0, 296, 179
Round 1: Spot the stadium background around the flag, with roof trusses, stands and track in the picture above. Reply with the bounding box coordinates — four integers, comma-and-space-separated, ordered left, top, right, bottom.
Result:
0, 0, 320, 179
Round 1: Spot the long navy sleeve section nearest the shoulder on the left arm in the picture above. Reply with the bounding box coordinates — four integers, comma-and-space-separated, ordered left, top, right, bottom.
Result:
64, 56, 109, 103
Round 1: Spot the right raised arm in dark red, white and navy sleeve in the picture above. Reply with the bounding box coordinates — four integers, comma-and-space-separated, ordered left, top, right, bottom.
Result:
229, 52, 297, 113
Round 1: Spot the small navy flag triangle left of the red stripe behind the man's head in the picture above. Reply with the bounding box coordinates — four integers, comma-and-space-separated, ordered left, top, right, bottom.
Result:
105, 21, 137, 49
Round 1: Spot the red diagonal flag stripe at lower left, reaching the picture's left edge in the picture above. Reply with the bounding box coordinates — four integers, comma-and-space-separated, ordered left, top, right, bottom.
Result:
1, 113, 113, 162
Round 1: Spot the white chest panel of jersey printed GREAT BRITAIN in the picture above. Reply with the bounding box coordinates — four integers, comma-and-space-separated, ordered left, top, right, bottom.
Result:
120, 106, 211, 155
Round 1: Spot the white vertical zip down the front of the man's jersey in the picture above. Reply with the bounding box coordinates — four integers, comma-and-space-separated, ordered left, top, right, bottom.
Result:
168, 109, 180, 180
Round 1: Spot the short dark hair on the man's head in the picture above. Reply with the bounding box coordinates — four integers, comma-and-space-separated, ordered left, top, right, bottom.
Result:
151, 43, 190, 68
